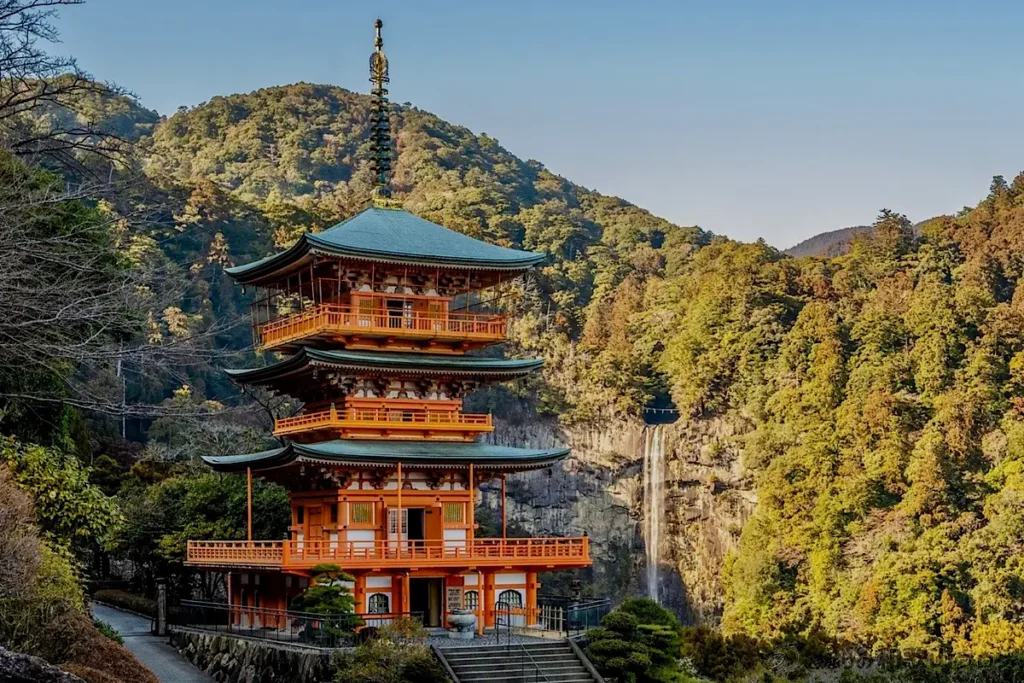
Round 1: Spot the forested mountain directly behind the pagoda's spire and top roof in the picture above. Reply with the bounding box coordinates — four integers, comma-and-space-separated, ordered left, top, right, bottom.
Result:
128, 84, 711, 420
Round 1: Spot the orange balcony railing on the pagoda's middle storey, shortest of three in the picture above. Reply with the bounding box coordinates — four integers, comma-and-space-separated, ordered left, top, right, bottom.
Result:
273, 407, 495, 436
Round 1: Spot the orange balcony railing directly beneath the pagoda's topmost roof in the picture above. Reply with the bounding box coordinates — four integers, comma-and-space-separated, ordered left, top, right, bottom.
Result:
256, 303, 508, 356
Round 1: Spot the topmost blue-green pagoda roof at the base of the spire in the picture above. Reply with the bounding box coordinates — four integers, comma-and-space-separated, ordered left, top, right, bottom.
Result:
226, 207, 545, 284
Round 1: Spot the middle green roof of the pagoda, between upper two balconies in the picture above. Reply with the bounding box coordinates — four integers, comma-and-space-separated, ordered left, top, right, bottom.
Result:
224, 347, 544, 385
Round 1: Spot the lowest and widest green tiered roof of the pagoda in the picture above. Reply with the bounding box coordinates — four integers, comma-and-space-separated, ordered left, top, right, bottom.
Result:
203, 439, 569, 472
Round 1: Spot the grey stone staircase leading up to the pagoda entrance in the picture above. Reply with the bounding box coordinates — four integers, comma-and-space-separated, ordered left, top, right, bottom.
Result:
437, 640, 604, 683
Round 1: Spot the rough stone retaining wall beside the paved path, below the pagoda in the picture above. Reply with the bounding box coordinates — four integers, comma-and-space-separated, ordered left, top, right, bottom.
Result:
171, 629, 332, 683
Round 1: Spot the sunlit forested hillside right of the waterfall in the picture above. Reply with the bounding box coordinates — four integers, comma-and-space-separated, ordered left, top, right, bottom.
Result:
643, 189, 1024, 657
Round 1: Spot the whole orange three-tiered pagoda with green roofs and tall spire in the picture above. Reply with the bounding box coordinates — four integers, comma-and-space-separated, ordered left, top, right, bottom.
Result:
187, 18, 591, 631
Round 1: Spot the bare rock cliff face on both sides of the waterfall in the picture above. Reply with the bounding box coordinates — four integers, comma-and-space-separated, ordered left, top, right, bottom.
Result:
483, 420, 756, 624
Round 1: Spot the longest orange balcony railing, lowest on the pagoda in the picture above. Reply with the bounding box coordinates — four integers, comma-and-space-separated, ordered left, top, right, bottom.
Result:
187, 537, 591, 568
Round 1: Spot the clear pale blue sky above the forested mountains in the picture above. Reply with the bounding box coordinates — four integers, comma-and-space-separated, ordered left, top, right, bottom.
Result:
56, 0, 1024, 247
